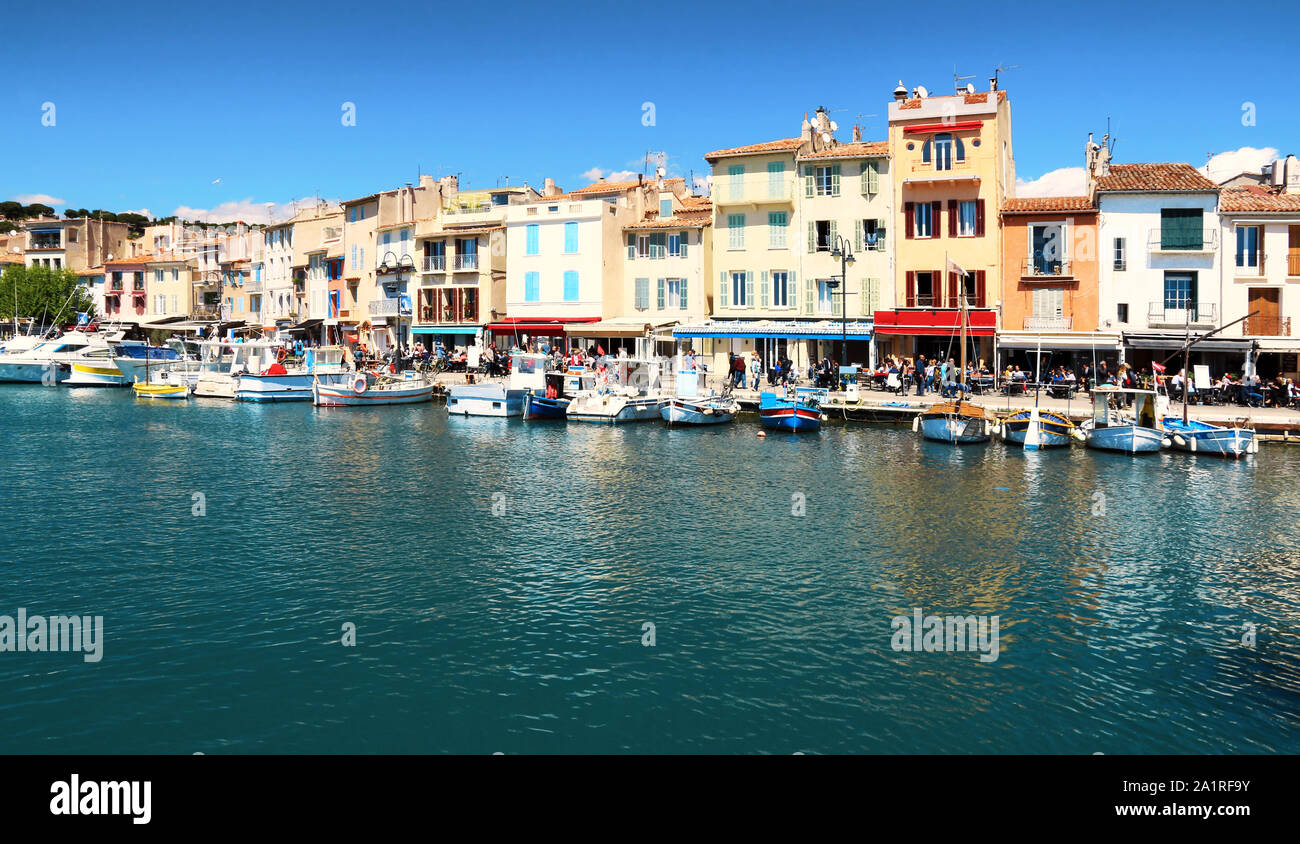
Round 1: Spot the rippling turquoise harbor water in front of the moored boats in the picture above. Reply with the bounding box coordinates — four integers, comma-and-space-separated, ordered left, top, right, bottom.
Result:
0, 386, 1300, 754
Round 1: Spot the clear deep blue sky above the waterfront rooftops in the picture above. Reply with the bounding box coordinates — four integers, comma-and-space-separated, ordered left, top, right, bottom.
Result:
0, 0, 1300, 218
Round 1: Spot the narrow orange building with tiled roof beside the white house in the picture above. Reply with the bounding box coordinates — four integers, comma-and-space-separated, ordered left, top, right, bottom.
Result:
997, 196, 1119, 369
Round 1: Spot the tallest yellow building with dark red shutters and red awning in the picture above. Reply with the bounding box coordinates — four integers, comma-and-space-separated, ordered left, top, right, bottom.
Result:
875, 83, 1015, 360
